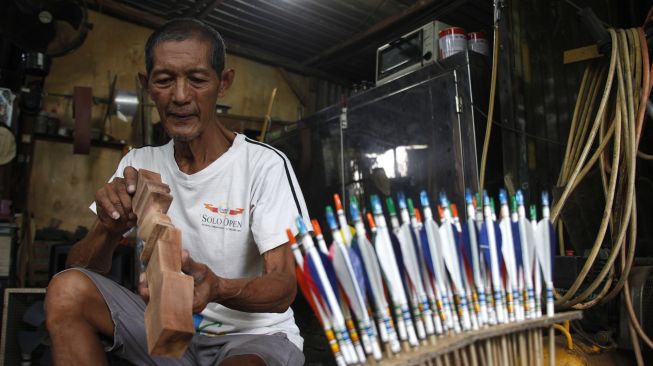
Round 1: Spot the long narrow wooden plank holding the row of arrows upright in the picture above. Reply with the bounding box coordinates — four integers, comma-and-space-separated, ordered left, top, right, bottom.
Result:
380, 311, 582, 366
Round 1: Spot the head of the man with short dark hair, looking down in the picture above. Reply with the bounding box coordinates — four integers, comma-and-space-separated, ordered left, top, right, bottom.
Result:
139, 19, 234, 141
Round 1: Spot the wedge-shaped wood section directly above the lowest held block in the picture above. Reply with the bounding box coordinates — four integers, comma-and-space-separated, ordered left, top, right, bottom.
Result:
146, 228, 181, 274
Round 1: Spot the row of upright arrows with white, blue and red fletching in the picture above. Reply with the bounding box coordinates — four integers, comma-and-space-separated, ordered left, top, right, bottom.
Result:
287, 190, 555, 365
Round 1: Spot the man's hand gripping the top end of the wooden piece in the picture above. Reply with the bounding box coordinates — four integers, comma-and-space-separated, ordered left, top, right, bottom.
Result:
95, 166, 138, 234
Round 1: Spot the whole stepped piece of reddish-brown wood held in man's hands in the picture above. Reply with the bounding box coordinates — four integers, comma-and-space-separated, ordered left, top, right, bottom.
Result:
132, 169, 195, 358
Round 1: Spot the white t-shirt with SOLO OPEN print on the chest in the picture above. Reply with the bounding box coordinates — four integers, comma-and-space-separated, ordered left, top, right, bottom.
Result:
91, 134, 311, 350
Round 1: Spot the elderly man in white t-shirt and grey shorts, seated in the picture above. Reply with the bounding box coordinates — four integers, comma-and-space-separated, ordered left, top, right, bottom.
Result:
45, 19, 310, 365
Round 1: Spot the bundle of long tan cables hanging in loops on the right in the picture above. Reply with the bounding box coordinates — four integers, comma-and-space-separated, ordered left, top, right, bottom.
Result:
551, 16, 653, 348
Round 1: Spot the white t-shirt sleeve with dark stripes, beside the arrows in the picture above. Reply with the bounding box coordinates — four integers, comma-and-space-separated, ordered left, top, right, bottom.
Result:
250, 154, 311, 254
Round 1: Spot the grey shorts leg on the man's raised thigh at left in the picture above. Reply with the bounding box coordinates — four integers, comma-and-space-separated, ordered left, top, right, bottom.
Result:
64, 268, 195, 366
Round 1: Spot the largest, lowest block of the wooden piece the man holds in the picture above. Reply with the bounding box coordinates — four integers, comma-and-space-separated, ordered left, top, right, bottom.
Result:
145, 272, 195, 358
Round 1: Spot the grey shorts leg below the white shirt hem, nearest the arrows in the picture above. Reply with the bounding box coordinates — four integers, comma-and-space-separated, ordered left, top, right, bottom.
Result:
193, 333, 304, 366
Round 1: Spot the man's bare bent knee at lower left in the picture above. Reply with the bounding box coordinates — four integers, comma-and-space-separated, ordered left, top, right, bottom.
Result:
44, 270, 102, 329
